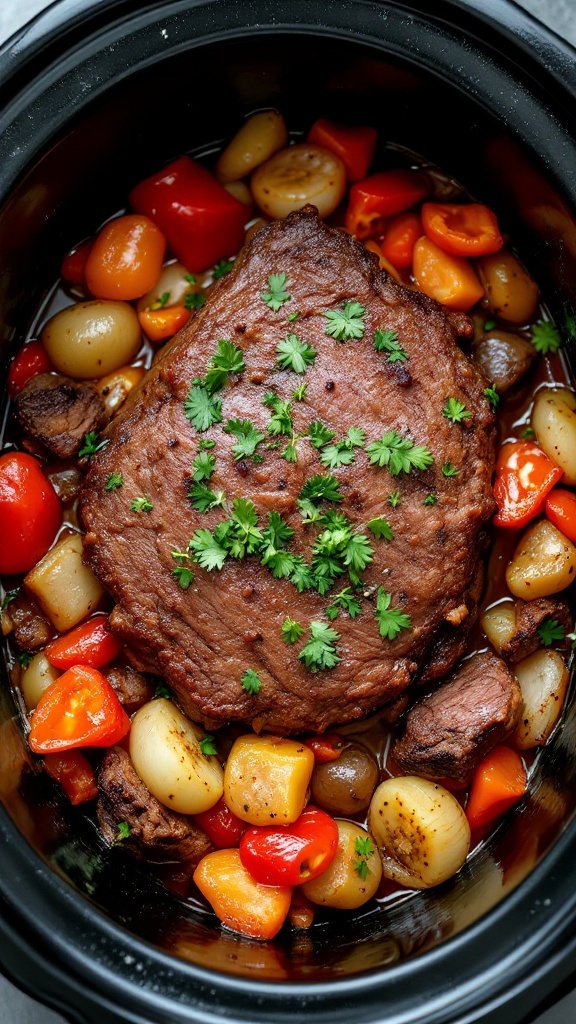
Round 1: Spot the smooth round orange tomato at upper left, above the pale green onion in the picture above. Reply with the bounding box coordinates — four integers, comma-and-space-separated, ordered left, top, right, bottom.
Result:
85, 213, 166, 300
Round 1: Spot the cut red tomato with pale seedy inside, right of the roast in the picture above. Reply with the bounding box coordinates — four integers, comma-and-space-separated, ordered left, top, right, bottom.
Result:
494, 441, 564, 529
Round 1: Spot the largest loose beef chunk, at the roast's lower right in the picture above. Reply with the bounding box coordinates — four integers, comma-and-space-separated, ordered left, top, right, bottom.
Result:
393, 653, 522, 781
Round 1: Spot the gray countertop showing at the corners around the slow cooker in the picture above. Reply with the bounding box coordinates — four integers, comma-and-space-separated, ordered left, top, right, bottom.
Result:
0, 0, 576, 1024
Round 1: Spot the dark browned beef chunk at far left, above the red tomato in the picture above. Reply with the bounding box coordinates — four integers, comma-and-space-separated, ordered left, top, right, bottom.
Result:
14, 374, 107, 459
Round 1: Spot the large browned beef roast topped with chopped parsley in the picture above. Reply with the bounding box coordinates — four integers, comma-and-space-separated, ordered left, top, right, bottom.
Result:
81, 207, 495, 733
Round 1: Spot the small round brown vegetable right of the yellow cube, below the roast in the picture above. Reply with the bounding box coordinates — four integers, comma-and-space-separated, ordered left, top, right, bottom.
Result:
312, 743, 378, 815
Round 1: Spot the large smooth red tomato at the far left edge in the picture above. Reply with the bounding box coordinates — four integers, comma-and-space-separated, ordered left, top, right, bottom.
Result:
0, 452, 61, 575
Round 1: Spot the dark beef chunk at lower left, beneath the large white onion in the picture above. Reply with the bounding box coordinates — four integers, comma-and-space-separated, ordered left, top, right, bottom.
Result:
97, 746, 210, 865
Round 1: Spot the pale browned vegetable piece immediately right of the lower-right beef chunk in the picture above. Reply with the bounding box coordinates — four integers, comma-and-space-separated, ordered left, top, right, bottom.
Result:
513, 649, 569, 751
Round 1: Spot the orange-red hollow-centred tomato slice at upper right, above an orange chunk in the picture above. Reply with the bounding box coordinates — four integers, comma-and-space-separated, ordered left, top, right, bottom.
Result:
416, 203, 504, 256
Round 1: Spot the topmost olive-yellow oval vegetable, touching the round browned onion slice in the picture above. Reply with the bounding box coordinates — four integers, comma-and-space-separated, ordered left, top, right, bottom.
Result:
216, 111, 288, 183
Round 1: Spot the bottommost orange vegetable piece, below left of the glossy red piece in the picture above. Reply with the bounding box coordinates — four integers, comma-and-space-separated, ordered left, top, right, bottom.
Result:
194, 850, 292, 939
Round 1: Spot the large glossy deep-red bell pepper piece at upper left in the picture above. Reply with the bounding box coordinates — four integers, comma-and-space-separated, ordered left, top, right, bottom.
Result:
130, 157, 246, 273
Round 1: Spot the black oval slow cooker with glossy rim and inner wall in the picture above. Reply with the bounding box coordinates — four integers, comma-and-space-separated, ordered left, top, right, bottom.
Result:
0, 0, 576, 1024
